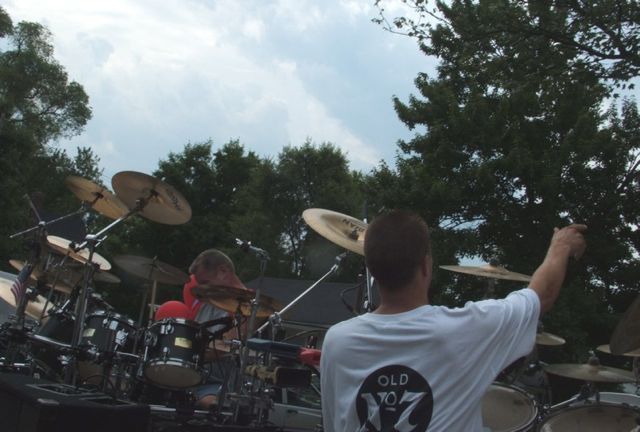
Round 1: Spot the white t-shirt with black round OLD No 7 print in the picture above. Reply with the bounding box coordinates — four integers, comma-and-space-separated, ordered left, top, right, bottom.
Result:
320, 288, 540, 432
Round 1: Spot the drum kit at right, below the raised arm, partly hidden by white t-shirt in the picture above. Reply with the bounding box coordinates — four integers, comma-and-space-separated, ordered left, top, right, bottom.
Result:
440, 263, 640, 432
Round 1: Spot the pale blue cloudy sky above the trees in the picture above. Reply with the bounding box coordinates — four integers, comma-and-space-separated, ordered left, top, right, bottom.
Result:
5, 0, 430, 176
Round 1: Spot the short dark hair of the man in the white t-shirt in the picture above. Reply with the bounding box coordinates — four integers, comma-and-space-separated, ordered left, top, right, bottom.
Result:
364, 210, 431, 290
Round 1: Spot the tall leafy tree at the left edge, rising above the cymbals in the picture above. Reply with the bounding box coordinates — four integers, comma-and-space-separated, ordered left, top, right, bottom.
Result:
0, 8, 91, 265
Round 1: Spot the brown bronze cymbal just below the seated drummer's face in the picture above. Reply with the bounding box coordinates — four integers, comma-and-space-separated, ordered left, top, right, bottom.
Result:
192, 285, 282, 318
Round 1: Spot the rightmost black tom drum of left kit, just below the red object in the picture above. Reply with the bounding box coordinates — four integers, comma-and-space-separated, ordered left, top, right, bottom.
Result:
144, 318, 205, 389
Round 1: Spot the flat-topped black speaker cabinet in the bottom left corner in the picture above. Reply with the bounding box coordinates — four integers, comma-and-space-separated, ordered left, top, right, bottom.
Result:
0, 373, 150, 432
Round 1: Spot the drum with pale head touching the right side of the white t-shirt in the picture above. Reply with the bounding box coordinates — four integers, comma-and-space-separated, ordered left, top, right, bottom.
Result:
482, 383, 538, 432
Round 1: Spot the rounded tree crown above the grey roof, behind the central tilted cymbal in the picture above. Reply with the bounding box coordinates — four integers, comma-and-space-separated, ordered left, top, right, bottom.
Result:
234, 140, 363, 277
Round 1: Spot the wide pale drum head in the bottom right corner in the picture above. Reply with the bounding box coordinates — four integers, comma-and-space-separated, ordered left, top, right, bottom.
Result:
538, 403, 640, 432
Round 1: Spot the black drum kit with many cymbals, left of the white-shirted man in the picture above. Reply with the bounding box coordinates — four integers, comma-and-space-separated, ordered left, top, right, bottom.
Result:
0, 171, 328, 430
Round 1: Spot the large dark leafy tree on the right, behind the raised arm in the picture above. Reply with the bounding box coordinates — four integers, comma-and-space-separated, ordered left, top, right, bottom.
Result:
373, 1, 640, 361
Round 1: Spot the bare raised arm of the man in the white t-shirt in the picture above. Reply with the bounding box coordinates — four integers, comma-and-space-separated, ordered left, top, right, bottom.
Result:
529, 224, 587, 313
